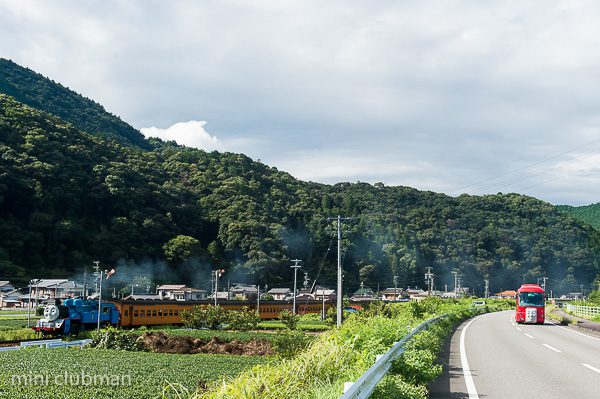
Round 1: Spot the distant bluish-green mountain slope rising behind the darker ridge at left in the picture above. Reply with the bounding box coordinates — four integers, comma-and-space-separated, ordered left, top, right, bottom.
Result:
0, 58, 150, 149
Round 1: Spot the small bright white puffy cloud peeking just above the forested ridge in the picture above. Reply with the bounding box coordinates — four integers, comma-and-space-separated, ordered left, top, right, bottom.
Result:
140, 120, 224, 151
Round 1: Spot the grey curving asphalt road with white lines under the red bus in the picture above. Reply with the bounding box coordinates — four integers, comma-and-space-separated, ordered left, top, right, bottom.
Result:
430, 311, 600, 399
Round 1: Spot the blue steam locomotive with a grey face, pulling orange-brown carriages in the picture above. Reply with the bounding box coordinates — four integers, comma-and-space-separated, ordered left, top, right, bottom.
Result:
33, 299, 119, 336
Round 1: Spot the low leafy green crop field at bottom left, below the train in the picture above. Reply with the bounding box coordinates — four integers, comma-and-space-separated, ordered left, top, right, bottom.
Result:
0, 348, 269, 399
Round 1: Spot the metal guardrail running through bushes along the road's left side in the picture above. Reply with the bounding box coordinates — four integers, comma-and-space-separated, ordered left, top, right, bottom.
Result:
340, 315, 447, 399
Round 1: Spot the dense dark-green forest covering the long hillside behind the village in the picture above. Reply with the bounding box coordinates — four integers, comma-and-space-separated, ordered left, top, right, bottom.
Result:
0, 61, 600, 293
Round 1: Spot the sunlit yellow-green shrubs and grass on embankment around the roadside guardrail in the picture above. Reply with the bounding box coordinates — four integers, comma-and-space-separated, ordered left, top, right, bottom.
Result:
193, 298, 510, 399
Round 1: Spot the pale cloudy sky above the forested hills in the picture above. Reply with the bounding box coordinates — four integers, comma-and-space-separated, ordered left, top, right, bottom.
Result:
0, 0, 600, 205
